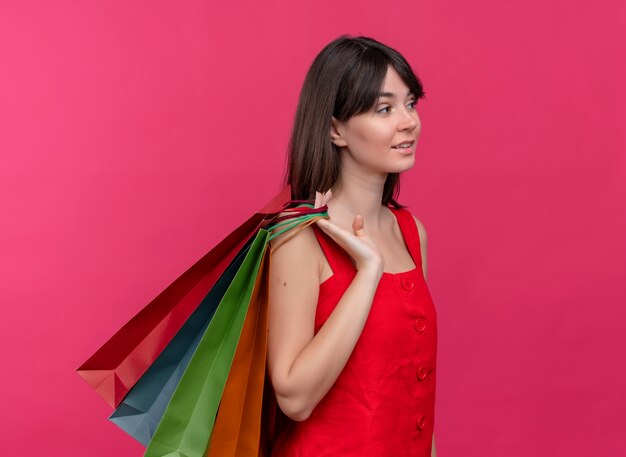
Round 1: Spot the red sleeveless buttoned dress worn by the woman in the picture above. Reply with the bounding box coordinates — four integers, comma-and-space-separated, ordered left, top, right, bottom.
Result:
271, 207, 437, 457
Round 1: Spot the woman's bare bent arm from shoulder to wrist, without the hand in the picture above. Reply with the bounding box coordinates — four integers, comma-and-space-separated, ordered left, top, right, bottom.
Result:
267, 205, 382, 420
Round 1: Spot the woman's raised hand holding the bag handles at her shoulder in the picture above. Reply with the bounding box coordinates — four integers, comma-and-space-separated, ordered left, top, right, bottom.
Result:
315, 189, 383, 276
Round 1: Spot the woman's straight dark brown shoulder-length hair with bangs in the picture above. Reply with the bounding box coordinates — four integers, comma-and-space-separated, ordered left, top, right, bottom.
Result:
284, 35, 425, 208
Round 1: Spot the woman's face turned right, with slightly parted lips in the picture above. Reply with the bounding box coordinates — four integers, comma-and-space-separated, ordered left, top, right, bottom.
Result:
331, 66, 421, 174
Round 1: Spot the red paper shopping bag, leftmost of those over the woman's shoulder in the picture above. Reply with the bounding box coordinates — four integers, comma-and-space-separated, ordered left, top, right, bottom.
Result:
76, 186, 290, 407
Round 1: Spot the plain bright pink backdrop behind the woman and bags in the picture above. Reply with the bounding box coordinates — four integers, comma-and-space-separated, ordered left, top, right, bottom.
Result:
0, 0, 626, 457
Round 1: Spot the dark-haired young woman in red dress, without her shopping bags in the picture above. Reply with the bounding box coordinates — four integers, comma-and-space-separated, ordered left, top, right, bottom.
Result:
267, 35, 437, 457
